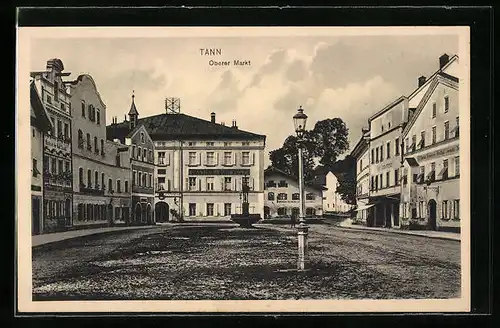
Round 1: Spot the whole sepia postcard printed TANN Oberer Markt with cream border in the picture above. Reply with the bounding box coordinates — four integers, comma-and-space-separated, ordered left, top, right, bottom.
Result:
16, 26, 470, 313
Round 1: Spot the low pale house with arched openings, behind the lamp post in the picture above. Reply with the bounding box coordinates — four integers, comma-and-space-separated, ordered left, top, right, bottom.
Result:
264, 167, 325, 219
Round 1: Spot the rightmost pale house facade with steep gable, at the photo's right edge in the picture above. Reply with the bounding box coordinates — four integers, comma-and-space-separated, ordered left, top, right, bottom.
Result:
401, 72, 460, 231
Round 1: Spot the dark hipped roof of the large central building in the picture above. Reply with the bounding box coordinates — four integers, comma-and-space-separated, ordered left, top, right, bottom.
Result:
106, 113, 266, 141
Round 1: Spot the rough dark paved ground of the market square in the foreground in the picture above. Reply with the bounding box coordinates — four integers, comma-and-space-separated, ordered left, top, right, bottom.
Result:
33, 224, 460, 300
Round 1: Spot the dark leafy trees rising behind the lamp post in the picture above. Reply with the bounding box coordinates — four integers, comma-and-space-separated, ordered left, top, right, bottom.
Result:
269, 118, 349, 182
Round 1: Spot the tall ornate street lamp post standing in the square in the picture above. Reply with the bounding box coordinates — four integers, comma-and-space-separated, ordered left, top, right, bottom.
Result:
293, 106, 309, 271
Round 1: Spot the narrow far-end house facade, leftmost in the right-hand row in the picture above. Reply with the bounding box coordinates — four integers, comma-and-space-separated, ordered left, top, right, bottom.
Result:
351, 130, 373, 224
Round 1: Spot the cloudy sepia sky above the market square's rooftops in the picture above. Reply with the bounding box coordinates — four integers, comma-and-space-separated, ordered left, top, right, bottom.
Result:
30, 34, 458, 165
